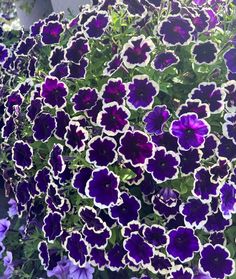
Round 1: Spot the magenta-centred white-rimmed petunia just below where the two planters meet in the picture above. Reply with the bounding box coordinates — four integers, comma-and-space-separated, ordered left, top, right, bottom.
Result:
41, 21, 64, 45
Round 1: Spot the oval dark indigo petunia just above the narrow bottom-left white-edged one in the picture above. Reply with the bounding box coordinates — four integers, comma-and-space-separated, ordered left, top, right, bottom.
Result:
42, 212, 62, 242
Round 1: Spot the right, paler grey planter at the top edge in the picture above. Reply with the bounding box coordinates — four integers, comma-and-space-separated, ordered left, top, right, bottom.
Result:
51, 0, 90, 17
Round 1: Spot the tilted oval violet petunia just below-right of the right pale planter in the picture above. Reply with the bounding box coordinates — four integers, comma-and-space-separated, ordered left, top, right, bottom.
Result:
84, 11, 110, 40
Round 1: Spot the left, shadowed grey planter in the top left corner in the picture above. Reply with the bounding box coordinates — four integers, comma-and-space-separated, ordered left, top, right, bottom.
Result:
15, 0, 53, 30
